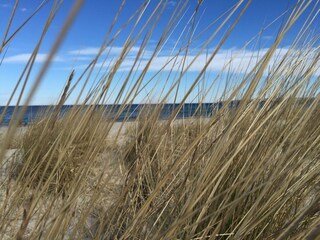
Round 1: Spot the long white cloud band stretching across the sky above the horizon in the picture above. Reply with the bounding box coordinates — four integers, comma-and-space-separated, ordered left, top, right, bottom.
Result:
3, 46, 320, 75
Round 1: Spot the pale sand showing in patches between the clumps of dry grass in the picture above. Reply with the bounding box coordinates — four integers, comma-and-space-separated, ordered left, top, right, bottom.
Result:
0, 120, 205, 239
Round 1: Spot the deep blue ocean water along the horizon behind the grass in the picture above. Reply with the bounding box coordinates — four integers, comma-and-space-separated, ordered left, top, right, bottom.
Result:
0, 101, 239, 125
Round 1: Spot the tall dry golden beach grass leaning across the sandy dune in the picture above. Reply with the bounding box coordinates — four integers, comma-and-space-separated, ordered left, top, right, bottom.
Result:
0, 0, 320, 240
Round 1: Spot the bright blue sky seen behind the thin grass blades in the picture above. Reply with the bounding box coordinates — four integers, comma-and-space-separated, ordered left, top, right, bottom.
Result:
0, 0, 319, 105
